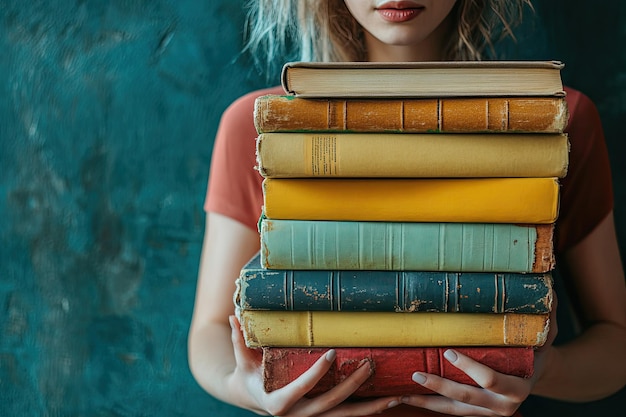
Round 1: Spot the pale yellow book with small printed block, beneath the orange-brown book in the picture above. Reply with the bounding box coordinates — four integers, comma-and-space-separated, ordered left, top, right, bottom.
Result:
257, 133, 569, 178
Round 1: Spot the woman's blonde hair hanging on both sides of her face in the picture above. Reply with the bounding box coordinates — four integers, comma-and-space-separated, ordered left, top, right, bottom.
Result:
246, 0, 532, 67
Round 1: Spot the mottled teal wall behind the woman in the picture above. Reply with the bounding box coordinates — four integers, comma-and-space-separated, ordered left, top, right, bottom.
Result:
0, 0, 626, 417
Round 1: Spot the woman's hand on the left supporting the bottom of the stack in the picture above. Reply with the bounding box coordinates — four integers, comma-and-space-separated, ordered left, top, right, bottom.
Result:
227, 316, 400, 417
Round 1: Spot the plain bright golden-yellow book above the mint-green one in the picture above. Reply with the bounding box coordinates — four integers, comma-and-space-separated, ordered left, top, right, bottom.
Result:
263, 177, 559, 224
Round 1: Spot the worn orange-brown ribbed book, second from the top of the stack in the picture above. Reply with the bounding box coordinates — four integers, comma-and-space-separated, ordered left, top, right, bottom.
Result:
254, 95, 568, 133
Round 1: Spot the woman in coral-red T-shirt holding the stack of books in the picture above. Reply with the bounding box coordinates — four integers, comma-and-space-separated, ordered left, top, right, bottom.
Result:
189, 0, 626, 416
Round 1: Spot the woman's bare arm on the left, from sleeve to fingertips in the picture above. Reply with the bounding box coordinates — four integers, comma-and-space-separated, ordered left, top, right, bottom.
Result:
188, 213, 400, 417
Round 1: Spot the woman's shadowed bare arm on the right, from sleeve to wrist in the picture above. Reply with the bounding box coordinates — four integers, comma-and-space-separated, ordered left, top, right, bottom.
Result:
532, 212, 626, 401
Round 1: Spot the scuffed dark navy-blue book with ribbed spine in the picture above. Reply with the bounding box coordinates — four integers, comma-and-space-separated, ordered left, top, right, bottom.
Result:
235, 268, 552, 314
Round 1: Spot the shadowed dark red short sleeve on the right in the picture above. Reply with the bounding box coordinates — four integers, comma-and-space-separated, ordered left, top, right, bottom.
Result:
555, 88, 613, 253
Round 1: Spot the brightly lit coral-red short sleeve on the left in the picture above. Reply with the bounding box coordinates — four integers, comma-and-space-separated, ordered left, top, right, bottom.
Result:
204, 88, 283, 230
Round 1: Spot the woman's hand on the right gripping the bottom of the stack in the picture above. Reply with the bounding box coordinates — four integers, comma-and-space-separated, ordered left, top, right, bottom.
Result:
401, 293, 558, 416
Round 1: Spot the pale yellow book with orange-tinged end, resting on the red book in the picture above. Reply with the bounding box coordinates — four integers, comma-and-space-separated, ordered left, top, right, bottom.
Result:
238, 310, 549, 347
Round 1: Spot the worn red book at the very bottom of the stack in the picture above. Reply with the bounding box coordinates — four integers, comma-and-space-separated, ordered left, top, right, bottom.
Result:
263, 346, 534, 397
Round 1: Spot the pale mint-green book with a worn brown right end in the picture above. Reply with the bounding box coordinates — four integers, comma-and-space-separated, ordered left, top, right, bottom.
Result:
259, 218, 555, 273
